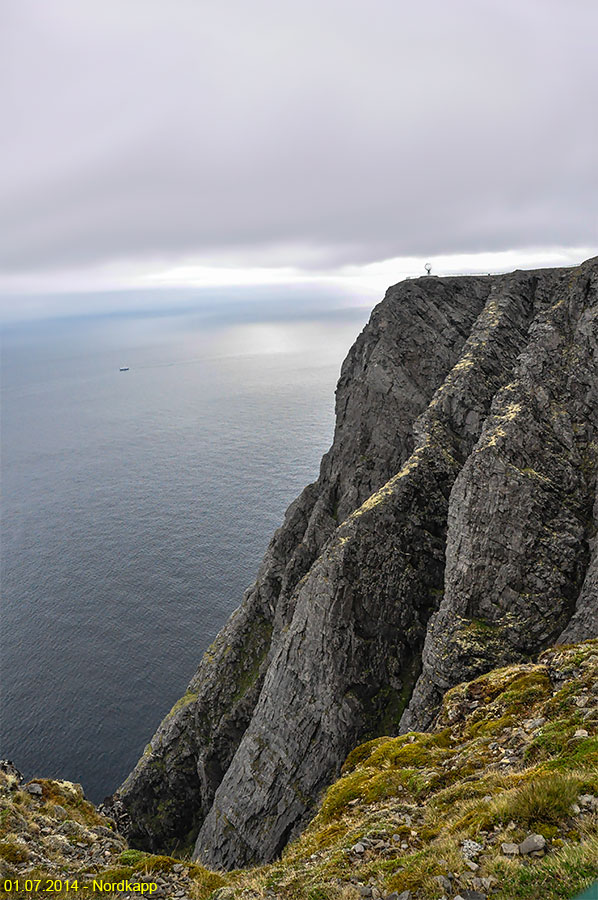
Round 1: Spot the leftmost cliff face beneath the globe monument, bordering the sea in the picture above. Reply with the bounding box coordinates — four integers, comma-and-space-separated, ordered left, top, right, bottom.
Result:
120, 278, 491, 850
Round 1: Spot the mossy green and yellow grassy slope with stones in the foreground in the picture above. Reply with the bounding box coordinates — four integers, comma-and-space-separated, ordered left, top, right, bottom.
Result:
0, 640, 598, 900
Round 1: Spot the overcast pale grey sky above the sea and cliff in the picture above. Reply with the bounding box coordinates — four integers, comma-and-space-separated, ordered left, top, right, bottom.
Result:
0, 0, 598, 316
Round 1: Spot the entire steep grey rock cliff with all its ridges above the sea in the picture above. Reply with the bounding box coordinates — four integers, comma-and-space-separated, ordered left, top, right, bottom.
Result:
120, 260, 598, 867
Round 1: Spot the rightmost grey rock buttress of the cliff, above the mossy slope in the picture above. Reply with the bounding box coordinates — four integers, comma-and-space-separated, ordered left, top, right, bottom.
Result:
402, 261, 598, 731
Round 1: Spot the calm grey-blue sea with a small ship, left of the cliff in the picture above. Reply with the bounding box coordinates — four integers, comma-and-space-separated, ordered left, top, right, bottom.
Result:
0, 298, 367, 801
